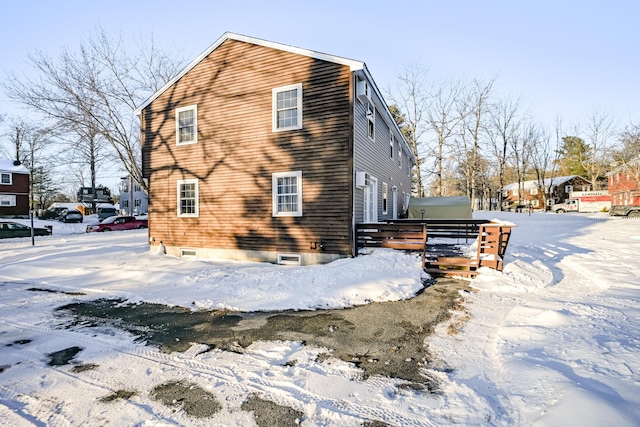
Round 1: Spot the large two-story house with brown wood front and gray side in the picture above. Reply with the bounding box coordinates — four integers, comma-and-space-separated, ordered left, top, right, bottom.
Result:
136, 33, 415, 265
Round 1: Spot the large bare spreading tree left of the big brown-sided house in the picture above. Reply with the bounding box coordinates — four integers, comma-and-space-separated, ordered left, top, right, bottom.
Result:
2, 29, 183, 189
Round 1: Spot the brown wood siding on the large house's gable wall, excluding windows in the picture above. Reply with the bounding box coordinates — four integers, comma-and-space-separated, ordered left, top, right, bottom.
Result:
141, 40, 352, 255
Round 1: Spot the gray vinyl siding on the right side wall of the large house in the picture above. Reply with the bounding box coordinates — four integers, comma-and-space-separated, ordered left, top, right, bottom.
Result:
353, 75, 411, 224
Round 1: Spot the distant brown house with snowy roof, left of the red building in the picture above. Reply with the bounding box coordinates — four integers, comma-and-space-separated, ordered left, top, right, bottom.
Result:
502, 175, 592, 210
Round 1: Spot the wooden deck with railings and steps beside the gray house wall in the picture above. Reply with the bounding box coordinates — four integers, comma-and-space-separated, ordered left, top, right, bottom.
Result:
357, 219, 512, 277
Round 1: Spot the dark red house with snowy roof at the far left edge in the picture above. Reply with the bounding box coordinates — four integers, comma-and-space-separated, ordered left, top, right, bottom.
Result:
0, 159, 29, 218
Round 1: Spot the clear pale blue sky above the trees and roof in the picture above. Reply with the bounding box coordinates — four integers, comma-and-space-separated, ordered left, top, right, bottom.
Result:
0, 0, 640, 186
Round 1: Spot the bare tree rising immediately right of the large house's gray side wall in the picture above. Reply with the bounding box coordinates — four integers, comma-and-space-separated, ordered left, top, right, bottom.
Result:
386, 63, 428, 197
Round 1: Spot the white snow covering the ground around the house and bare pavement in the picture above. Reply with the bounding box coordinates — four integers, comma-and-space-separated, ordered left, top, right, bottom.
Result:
0, 212, 640, 426
